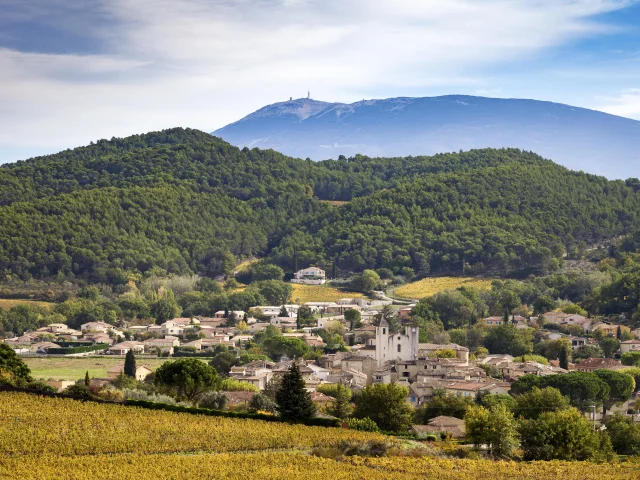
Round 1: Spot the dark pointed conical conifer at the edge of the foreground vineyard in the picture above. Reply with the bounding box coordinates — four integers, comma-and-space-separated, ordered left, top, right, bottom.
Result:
276, 362, 316, 423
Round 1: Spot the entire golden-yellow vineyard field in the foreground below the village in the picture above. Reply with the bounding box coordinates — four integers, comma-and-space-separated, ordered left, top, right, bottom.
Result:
0, 393, 638, 480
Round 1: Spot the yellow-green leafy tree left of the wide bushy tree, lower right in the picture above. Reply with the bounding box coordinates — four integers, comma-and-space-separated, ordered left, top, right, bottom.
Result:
464, 403, 518, 458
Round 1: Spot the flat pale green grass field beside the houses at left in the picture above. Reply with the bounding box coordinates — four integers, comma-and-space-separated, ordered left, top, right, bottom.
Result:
24, 356, 171, 380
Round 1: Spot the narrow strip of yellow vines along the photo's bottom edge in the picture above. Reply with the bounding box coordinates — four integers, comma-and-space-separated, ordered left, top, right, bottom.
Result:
0, 452, 639, 480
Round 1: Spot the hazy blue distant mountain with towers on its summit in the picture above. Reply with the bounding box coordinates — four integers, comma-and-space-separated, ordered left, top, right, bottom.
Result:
213, 95, 640, 179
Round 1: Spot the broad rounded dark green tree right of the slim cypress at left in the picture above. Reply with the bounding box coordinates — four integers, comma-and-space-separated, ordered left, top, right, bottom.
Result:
154, 358, 222, 402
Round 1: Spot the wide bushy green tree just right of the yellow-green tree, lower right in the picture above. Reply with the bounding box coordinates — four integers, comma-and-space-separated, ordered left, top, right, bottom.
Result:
520, 408, 611, 461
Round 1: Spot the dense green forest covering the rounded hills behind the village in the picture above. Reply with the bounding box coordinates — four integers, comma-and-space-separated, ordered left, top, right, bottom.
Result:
0, 129, 640, 283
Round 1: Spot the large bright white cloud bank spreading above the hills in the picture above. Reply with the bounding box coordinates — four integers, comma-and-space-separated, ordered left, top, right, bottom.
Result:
0, 0, 629, 162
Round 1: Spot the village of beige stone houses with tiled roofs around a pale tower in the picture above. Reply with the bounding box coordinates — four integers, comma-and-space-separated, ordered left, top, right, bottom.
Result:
4, 268, 640, 434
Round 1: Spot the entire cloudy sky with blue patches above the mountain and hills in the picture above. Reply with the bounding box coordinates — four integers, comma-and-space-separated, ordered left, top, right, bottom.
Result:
0, 0, 640, 163
